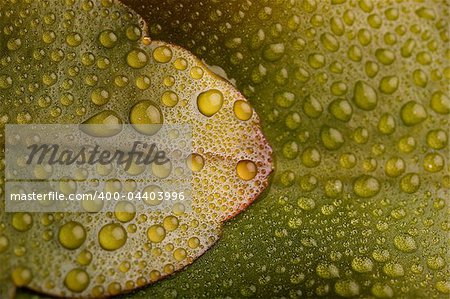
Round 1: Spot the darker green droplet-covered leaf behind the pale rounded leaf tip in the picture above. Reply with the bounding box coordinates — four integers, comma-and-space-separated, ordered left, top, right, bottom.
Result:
111, 0, 450, 298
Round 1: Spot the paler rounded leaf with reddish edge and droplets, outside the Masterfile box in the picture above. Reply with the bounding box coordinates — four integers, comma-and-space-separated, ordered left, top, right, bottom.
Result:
0, 0, 272, 298
